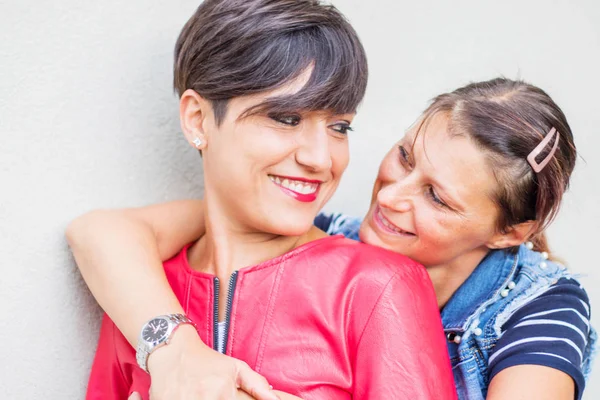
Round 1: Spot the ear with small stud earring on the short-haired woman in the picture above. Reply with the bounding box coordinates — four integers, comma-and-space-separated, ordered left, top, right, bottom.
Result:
179, 89, 212, 150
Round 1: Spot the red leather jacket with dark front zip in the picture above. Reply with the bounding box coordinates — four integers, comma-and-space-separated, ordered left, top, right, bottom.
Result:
87, 236, 456, 400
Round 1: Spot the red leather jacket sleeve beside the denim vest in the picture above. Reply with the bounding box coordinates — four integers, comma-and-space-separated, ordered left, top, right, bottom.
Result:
351, 252, 456, 400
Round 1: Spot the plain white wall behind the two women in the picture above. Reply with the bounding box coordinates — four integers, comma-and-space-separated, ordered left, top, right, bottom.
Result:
0, 0, 600, 400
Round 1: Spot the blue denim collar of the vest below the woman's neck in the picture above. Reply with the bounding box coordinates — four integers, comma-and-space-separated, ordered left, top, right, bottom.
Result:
441, 250, 518, 331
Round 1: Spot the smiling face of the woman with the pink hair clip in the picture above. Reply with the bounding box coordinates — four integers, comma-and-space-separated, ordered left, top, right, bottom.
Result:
360, 115, 499, 267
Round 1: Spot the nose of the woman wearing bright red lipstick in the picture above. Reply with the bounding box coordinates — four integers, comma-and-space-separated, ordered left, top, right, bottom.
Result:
296, 123, 332, 172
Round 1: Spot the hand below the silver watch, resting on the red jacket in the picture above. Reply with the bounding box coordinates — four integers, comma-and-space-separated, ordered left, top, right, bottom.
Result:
148, 325, 279, 400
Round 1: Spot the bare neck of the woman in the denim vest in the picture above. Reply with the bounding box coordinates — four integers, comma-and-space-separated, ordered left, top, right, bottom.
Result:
427, 247, 489, 309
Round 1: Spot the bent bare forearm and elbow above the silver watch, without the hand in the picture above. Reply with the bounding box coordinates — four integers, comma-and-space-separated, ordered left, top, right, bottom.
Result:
66, 200, 204, 347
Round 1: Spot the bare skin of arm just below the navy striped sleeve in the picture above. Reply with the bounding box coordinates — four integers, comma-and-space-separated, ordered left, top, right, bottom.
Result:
486, 365, 575, 400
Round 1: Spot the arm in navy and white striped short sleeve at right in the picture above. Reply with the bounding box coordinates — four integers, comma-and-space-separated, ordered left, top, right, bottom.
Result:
487, 278, 590, 400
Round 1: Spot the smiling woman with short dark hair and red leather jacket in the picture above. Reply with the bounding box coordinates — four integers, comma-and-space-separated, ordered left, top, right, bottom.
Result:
69, 0, 456, 400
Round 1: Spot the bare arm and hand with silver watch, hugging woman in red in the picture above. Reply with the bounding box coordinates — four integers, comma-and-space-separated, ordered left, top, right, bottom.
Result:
66, 200, 275, 399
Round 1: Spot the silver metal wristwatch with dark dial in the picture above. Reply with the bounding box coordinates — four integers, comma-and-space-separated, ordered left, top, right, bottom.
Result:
135, 314, 196, 372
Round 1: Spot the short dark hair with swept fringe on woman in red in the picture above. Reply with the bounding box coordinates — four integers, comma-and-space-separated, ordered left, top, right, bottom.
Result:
174, 0, 368, 123
